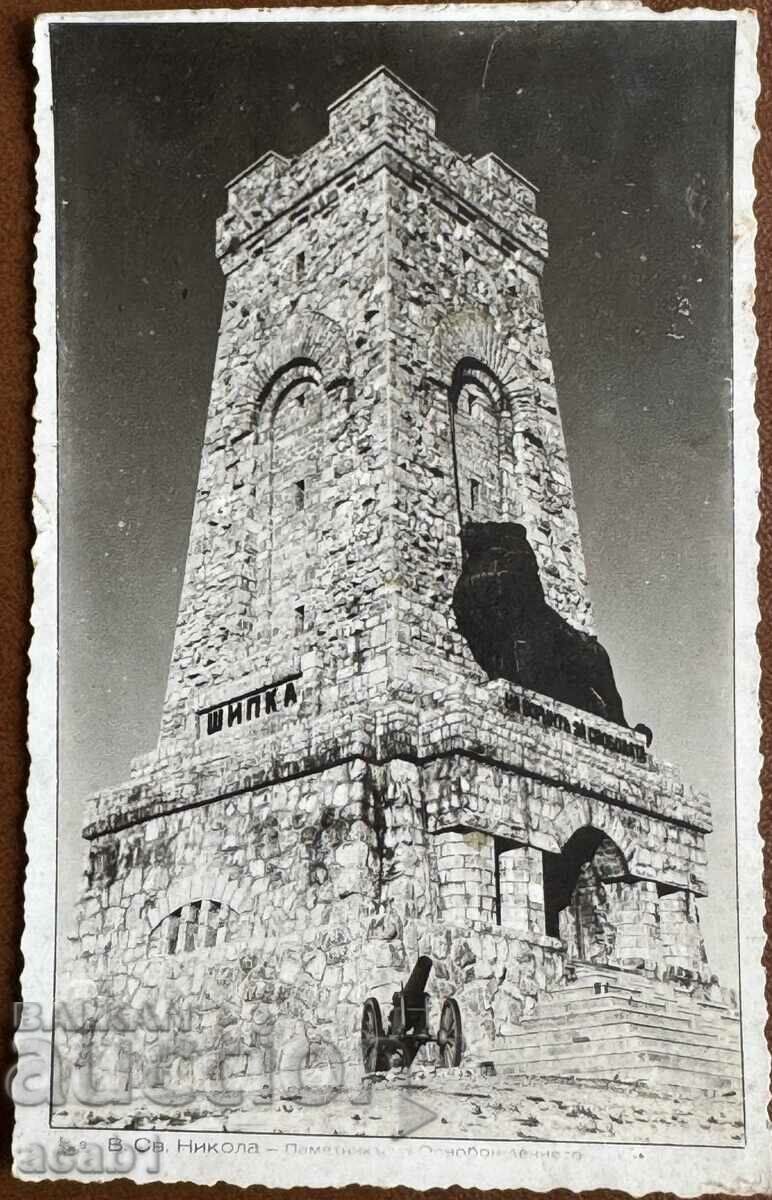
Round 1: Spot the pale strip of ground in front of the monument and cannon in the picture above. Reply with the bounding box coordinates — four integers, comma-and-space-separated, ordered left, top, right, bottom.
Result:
56, 1063, 744, 1146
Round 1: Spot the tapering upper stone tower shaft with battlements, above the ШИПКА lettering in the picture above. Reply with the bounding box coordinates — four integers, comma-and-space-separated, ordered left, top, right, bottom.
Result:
163, 63, 591, 737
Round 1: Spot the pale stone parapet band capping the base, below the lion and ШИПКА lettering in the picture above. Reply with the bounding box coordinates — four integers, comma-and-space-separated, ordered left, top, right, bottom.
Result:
86, 680, 711, 895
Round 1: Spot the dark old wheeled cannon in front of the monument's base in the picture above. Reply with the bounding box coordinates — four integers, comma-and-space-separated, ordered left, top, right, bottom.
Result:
361, 954, 462, 1074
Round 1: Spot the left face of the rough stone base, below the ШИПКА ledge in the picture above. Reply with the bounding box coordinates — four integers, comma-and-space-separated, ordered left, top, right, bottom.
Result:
76, 762, 388, 1070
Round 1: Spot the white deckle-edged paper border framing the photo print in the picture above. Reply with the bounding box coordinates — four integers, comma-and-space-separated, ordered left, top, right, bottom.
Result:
13, 7, 772, 1196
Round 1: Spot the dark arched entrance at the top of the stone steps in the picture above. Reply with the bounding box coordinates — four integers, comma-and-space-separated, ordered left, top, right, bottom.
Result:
544, 826, 630, 964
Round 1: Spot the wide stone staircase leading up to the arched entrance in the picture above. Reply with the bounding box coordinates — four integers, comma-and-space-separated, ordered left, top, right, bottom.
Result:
486, 965, 742, 1092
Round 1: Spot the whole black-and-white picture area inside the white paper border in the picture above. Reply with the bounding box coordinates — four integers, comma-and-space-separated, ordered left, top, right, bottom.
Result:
18, 11, 760, 1182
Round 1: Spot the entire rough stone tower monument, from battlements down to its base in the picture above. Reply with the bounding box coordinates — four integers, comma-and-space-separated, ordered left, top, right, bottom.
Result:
77, 68, 744, 1104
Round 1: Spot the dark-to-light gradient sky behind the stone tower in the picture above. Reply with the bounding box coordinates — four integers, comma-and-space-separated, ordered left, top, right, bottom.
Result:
52, 20, 736, 984
